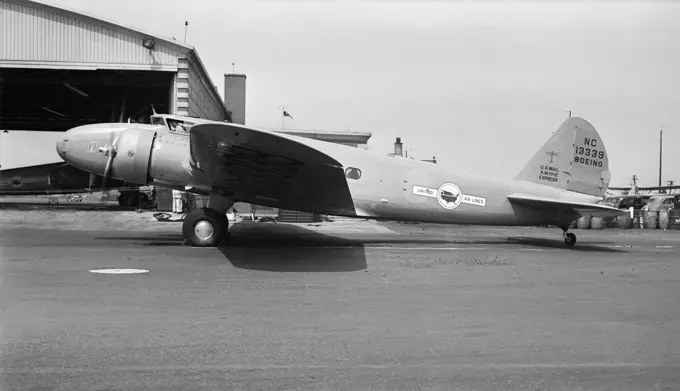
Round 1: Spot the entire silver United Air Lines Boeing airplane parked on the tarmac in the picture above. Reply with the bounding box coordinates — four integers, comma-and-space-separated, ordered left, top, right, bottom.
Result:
57, 115, 624, 247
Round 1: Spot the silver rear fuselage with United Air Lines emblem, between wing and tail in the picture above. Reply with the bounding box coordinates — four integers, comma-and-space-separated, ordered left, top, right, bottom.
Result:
270, 138, 600, 225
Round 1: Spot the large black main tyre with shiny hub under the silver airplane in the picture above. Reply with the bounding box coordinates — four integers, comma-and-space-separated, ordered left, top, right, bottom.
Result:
182, 208, 229, 247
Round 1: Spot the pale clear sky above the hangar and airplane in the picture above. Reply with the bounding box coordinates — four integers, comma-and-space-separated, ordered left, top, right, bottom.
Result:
1, 0, 680, 186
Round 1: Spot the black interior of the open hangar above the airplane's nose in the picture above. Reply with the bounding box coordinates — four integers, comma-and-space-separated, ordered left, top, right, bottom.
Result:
0, 68, 175, 131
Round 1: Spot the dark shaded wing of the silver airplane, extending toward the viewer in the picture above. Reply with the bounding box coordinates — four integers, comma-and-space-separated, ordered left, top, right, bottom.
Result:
190, 123, 355, 214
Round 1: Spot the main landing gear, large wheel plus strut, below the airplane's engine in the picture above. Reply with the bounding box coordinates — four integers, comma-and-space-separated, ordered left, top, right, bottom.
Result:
182, 194, 234, 247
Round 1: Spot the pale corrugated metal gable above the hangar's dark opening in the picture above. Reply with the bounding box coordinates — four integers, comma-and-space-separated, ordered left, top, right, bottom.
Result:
0, 0, 182, 70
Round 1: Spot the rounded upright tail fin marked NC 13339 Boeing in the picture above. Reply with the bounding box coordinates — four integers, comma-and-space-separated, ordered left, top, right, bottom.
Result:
515, 117, 611, 197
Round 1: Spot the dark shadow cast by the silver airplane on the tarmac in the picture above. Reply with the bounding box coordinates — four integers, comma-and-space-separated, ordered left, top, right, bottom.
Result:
95, 224, 626, 272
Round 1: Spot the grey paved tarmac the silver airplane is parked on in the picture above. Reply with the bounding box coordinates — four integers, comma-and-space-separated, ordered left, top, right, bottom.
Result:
0, 212, 680, 391
